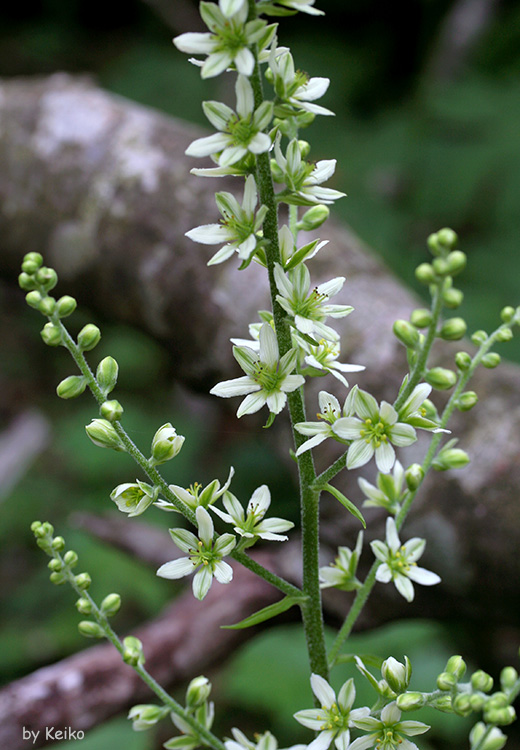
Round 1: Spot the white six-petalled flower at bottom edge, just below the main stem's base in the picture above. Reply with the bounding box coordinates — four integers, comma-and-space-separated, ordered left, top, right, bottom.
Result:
294, 674, 369, 750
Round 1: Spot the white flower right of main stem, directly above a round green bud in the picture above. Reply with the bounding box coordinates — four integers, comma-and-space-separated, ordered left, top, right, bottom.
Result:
273, 138, 345, 206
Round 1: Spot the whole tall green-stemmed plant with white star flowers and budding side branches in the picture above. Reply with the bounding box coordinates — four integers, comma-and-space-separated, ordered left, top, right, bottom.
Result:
20, 0, 520, 750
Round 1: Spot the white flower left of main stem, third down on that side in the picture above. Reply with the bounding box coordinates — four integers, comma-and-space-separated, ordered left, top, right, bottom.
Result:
186, 175, 267, 266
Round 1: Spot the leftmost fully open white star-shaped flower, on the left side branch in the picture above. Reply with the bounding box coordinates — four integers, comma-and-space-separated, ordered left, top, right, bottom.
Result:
157, 506, 236, 600
